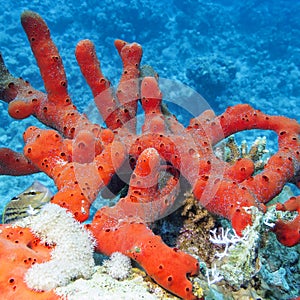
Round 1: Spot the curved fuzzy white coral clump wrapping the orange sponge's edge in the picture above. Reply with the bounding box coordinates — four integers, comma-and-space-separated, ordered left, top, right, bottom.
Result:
25, 203, 95, 291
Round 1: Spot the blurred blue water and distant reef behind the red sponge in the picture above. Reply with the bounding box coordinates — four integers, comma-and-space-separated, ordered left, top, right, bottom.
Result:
0, 0, 300, 208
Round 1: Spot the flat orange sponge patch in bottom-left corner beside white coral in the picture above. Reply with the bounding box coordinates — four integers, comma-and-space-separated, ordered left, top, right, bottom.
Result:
0, 225, 59, 300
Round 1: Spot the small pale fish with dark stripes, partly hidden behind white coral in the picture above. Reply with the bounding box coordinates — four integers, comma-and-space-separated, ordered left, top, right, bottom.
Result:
2, 181, 53, 224
